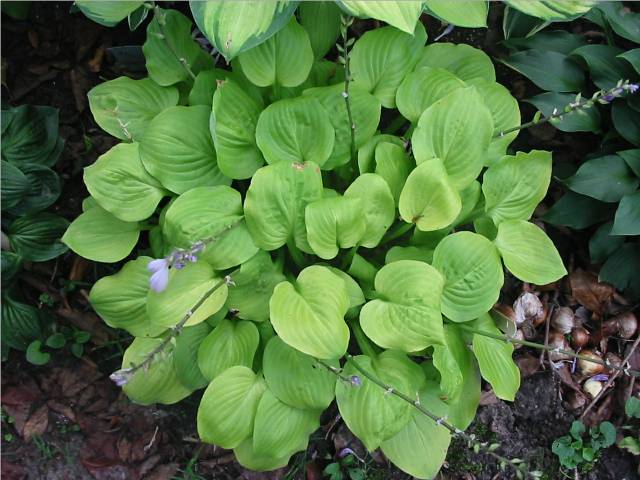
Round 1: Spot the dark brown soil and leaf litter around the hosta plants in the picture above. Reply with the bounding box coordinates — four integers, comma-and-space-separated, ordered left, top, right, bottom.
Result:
1, 2, 638, 480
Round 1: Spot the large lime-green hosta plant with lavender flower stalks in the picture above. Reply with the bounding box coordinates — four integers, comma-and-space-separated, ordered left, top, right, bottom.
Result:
64, 2, 565, 478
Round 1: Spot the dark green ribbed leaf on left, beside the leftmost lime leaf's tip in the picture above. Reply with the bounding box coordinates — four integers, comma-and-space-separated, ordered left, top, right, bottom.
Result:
7, 213, 69, 262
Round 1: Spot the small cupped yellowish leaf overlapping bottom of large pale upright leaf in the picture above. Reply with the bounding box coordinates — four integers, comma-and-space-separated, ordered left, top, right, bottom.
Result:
398, 158, 462, 231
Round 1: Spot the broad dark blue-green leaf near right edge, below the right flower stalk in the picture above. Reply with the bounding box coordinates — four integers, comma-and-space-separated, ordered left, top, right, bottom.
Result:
565, 155, 640, 202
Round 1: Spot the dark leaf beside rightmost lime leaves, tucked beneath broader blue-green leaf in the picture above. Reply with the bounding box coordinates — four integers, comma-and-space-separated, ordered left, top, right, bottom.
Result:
542, 192, 612, 229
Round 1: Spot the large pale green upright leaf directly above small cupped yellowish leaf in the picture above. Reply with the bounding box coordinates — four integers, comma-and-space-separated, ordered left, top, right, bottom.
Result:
411, 87, 493, 189
